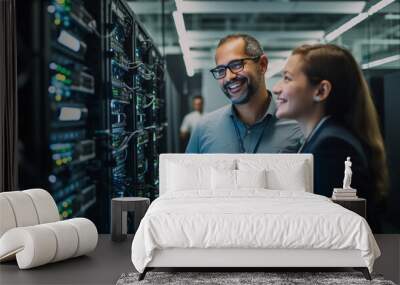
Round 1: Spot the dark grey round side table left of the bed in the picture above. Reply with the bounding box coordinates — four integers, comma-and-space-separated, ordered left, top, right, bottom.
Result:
111, 197, 150, 241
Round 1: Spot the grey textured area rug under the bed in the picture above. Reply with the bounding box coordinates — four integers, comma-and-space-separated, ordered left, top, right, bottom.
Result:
116, 271, 395, 285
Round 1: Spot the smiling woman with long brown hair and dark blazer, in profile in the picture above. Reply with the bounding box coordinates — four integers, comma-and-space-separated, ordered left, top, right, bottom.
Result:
273, 44, 388, 231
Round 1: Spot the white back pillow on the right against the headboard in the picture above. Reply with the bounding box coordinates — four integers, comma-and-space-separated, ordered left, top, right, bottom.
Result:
238, 159, 310, 191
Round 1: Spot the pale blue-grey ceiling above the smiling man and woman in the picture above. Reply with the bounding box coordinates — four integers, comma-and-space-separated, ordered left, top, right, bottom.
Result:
129, 0, 400, 74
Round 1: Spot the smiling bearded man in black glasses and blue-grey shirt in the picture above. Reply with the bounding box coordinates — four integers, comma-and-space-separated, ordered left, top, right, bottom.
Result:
186, 34, 302, 153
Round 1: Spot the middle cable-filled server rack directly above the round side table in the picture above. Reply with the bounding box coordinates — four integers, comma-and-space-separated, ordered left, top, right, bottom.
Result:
89, 0, 135, 232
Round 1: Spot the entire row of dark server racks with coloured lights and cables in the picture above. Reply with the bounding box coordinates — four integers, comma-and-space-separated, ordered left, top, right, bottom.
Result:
20, 0, 166, 233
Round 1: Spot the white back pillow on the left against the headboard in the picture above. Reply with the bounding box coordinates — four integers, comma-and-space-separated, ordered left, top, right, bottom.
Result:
166, 160, 236, 191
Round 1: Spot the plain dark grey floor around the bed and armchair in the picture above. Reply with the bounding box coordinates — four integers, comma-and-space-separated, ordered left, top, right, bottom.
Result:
0, 235, 400, 285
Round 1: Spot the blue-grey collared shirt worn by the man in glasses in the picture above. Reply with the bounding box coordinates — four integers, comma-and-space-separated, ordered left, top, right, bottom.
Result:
186, 94, 303, 153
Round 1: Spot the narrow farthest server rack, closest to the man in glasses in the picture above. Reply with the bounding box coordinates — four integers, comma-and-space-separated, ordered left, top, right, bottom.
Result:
135, 21, 167, 200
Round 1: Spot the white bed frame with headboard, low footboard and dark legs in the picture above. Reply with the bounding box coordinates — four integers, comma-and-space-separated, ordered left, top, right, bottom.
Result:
139, 154, 371, 280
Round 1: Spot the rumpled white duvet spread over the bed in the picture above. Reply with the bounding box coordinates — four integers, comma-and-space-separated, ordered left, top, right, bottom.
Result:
132, 189, 380, 272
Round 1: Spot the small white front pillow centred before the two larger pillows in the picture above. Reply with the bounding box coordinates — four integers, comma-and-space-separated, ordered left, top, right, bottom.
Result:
211, 168, 266, 190
